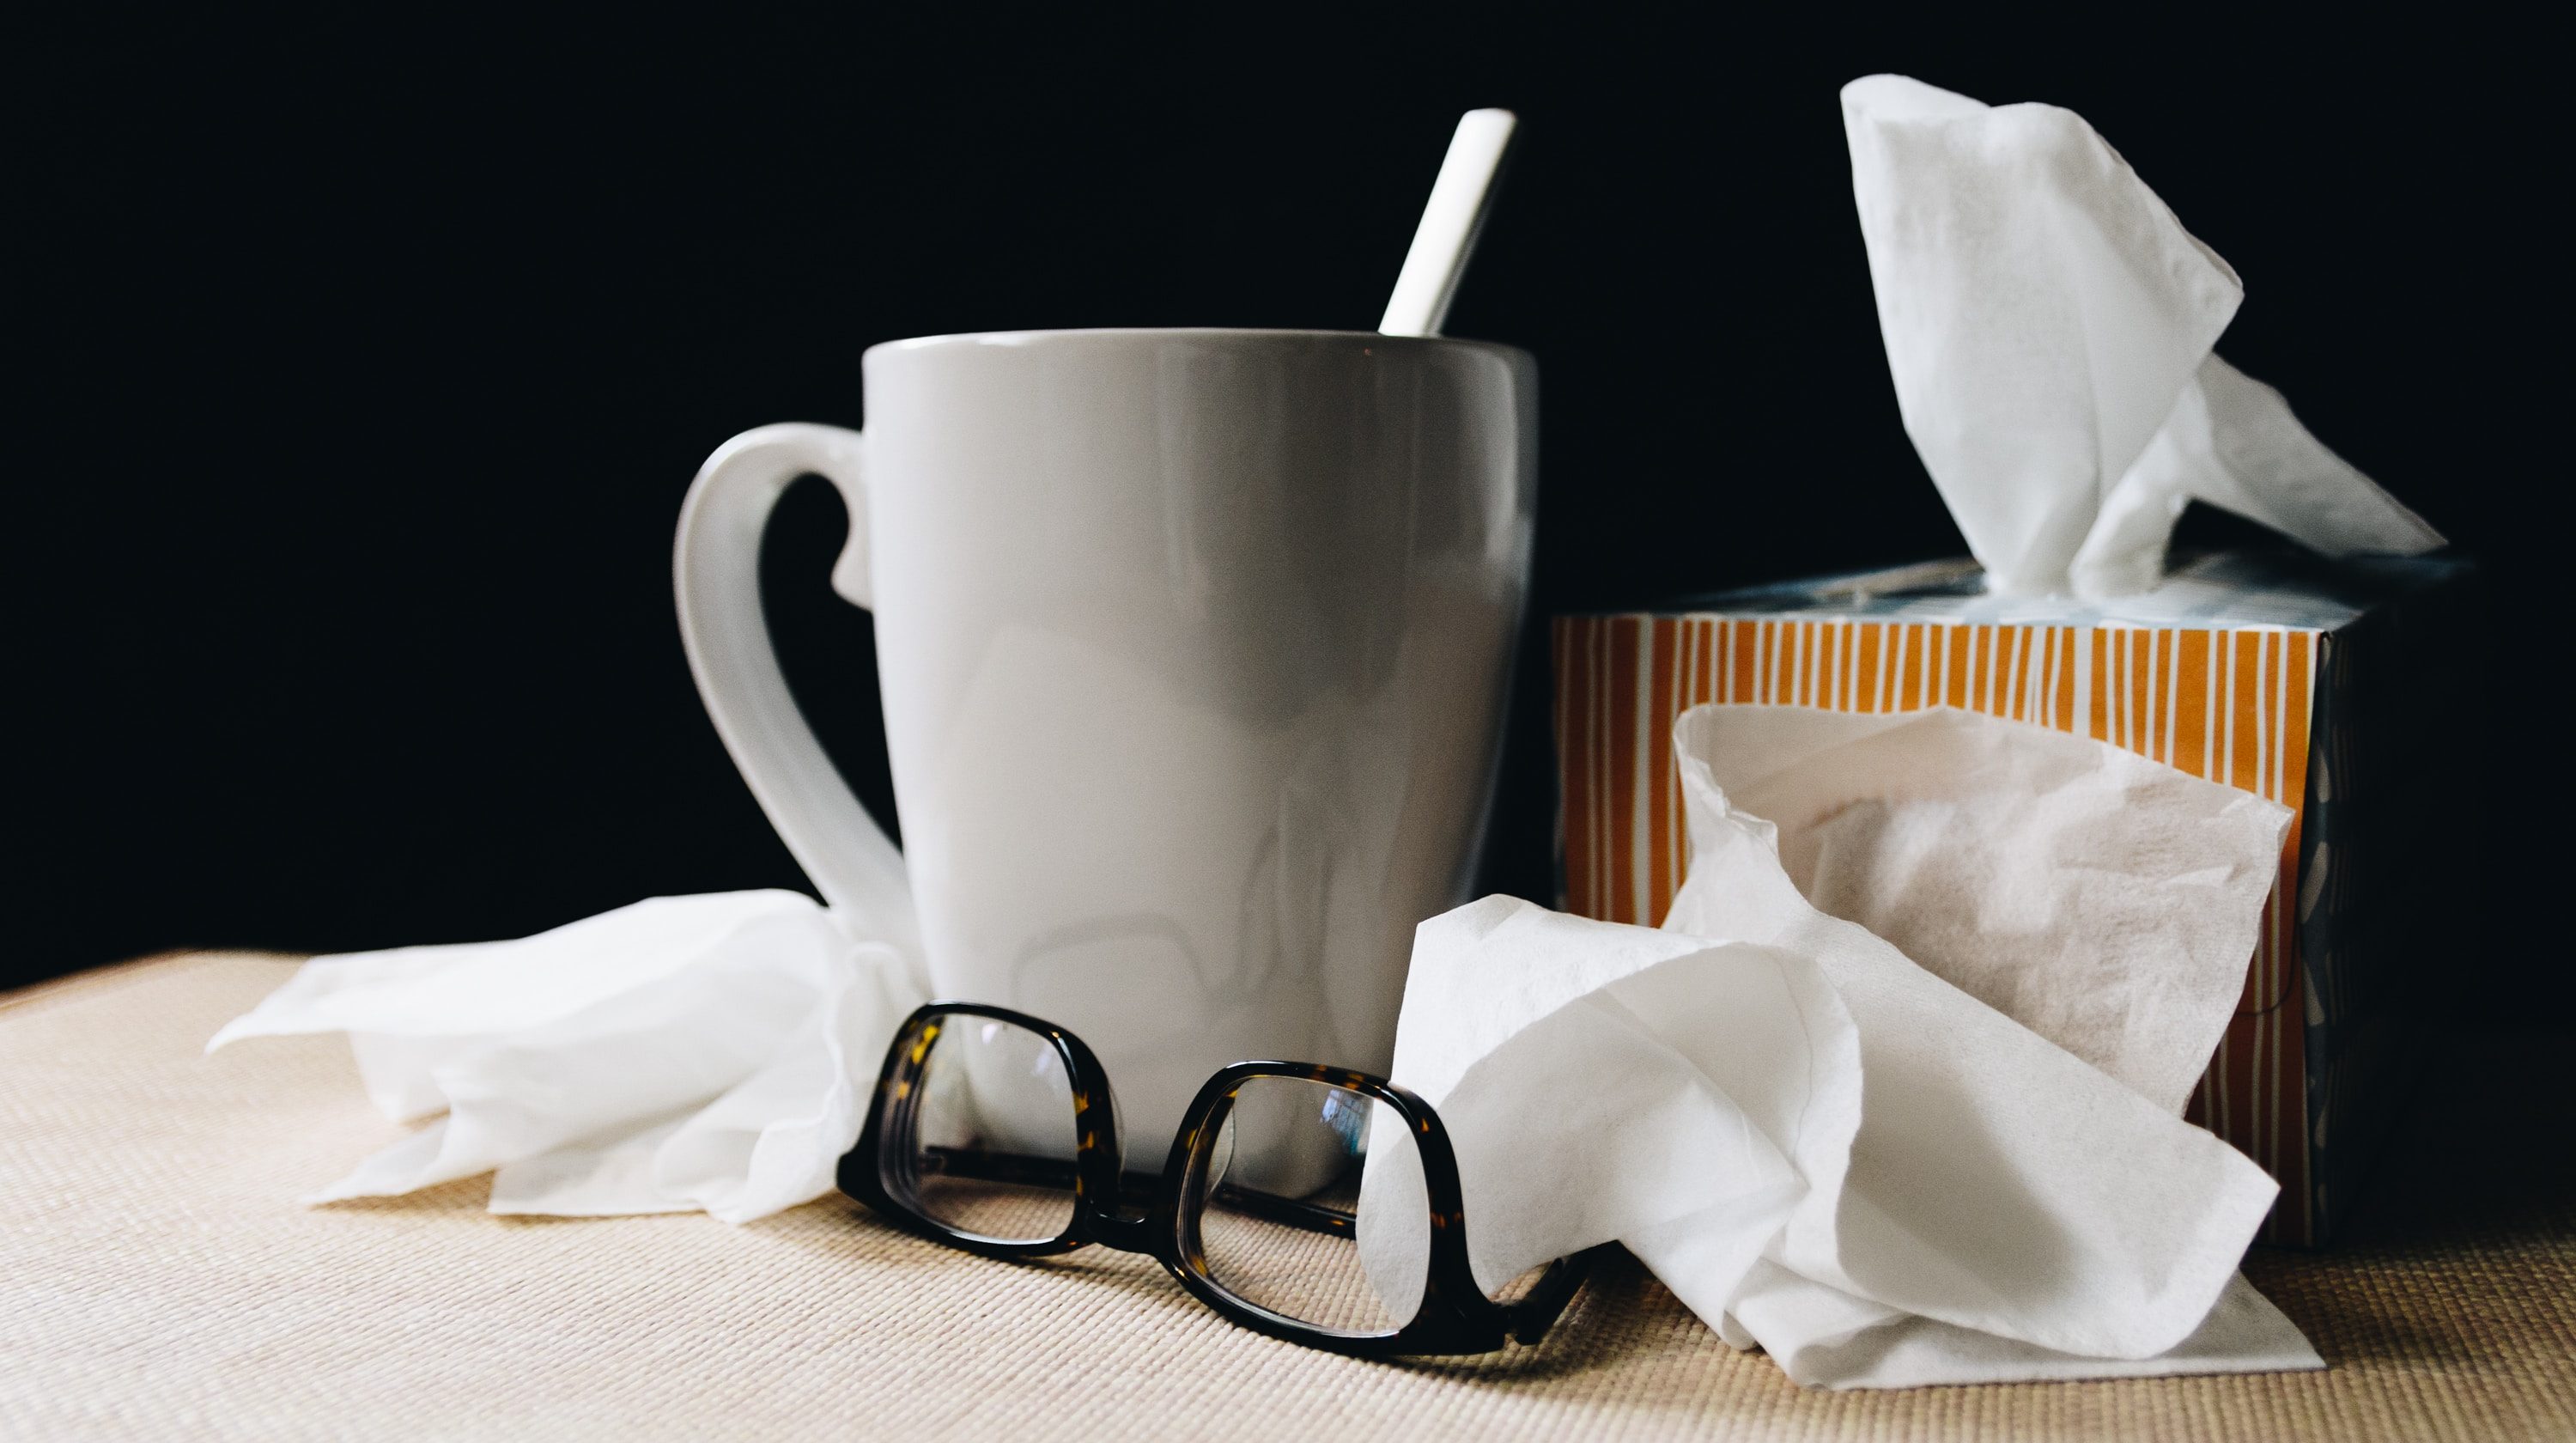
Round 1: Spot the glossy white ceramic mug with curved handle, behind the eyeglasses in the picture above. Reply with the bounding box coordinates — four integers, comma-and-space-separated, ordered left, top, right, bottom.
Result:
677, 330, 1538, 1170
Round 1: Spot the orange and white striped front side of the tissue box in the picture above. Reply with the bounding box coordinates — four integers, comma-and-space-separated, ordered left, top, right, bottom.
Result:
1553, 613, 2324, 1245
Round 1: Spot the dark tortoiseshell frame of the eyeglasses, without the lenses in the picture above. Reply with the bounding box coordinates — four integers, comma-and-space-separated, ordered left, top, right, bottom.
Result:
840, 1002, 1597, 1358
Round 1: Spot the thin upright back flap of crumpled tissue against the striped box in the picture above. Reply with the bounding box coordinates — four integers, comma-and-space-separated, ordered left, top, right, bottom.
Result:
1674, 706, 2290, 1113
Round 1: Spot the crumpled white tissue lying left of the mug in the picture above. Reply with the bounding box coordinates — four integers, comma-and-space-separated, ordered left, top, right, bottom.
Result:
206, 892, 920, 1221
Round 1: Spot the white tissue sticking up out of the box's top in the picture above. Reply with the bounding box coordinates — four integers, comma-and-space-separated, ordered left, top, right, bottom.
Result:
1842, 75, 2442, 600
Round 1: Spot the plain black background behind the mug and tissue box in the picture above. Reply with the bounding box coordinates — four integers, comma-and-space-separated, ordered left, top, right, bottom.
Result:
0, 5, 2568, 1008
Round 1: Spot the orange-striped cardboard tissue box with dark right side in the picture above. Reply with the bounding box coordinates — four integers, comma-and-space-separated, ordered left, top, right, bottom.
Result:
1553, 554, 2476, 1245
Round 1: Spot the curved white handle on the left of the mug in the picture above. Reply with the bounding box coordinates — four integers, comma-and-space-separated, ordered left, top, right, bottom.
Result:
672, 423, 920, 948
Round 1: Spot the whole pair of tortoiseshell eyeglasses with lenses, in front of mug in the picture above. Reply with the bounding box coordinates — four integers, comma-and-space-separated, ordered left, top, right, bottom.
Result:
840, 1002, 1592, 1355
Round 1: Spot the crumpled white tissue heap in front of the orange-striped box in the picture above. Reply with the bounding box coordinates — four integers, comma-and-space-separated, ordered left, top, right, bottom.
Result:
1360, 709, 2321, 1386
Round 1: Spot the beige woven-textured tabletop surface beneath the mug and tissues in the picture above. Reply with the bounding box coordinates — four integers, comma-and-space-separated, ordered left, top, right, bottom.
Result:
0, 956, 2576, 1443
